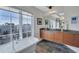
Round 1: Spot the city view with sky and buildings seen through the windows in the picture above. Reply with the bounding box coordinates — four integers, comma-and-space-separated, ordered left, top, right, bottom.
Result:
0, 9, 31, 45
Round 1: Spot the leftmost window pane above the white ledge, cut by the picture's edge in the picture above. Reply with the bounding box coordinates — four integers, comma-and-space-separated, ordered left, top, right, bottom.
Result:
0, 10, 10, 45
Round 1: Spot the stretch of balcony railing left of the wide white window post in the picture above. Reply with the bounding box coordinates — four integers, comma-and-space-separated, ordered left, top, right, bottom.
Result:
0, 33, 19, 44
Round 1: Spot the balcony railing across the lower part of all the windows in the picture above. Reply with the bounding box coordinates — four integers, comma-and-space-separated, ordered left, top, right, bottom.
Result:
0, 31, 31, 45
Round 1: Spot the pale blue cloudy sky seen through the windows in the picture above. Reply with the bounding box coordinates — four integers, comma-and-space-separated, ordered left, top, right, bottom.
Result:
0, 10, 31, 25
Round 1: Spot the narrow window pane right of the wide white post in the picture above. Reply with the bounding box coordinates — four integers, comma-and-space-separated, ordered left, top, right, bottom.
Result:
22, 15, 32, 38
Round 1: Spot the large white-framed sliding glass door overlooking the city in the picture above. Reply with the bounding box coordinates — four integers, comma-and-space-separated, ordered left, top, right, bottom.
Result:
0, 7, 33, 52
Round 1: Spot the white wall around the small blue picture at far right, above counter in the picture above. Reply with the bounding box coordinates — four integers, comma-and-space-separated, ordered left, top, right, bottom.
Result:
64, 6, 79, 31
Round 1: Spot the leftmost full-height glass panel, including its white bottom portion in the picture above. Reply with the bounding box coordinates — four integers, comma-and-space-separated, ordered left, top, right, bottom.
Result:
0, 9, 12, 52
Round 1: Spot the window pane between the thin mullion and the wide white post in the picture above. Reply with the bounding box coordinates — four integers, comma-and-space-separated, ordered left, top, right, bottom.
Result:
10, 12, 19, 40
